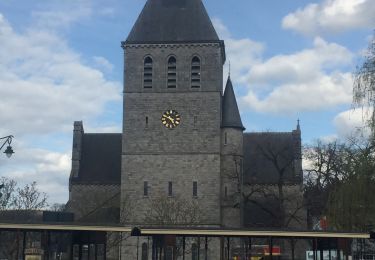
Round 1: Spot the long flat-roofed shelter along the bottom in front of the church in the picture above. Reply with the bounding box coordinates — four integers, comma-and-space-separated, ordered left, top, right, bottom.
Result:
0, 223, 375, 260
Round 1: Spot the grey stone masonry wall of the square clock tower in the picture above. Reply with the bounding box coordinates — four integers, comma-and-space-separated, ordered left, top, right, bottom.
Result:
121, 43, 223, 226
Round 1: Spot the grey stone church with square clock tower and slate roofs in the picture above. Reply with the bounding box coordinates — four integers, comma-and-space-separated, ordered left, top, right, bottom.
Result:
67, 0, 305, 259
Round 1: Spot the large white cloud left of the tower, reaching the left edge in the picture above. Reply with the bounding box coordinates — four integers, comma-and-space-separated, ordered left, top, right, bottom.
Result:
0, 14, 121, 135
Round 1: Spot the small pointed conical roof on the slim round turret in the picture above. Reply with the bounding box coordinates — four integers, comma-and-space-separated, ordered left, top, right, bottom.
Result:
221, 77, 245, 130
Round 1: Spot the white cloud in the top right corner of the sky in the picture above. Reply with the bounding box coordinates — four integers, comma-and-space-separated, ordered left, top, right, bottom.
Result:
282, 0, 375, 35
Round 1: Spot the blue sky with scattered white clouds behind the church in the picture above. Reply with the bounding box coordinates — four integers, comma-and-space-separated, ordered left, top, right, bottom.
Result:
0, 0, 375, 204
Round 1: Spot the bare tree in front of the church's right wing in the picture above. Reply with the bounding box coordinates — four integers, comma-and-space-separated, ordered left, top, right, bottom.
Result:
243, 136, 305, 230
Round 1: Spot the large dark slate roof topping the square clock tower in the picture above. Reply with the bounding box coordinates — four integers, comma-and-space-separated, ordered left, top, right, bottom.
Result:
125, 0, 219, 43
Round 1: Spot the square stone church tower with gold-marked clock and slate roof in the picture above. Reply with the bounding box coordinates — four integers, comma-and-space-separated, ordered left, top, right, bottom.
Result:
121, 0, 225, 227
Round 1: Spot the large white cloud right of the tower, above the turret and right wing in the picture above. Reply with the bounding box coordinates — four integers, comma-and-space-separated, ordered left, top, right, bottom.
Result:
214, 19, 353, 113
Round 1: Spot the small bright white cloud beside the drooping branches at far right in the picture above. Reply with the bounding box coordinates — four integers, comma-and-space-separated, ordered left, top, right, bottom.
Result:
333, 108, 372, 138
